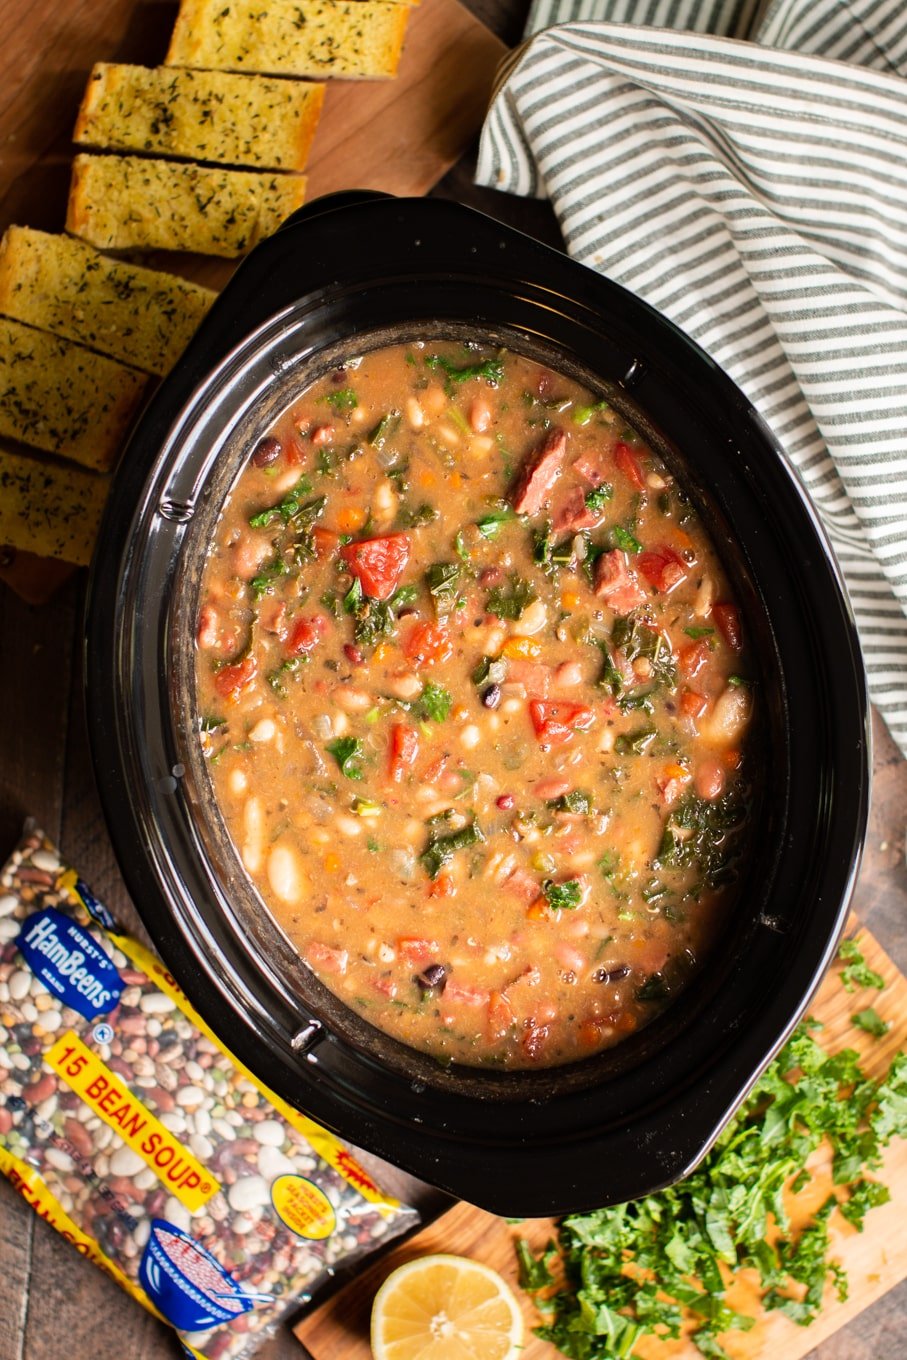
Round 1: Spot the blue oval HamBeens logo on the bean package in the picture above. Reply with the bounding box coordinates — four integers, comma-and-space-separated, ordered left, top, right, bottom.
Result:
16, 907, 122, 1020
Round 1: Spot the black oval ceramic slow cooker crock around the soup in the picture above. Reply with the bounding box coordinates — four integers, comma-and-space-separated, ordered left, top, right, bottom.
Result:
86, 193, 869, 1214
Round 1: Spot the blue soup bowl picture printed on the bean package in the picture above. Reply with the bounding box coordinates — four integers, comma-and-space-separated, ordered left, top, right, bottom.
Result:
139, 1219, 262, 1331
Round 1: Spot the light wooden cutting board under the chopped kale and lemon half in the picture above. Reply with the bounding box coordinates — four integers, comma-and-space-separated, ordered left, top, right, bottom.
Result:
295, 930, 907, 1360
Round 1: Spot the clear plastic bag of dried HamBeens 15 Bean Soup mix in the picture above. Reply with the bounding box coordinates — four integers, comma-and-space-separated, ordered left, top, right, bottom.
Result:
0, 827, 416, 1360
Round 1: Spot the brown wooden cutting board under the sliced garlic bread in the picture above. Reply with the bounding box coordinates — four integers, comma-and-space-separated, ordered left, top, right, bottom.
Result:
0, 0, 507, 604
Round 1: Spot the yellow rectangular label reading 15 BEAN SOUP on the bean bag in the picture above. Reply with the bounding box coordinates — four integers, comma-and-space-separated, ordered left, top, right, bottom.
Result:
44, 1030, 220, 1213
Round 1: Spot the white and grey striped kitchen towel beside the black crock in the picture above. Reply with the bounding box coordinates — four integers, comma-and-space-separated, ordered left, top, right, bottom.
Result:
476, 0, 907, 755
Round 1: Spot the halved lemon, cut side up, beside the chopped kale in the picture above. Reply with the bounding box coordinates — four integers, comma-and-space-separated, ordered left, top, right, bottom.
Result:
371, 1255, 524, 1360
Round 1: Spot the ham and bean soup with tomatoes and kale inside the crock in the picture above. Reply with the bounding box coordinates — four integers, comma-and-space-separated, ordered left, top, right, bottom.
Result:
197, 341, 752, 1068
